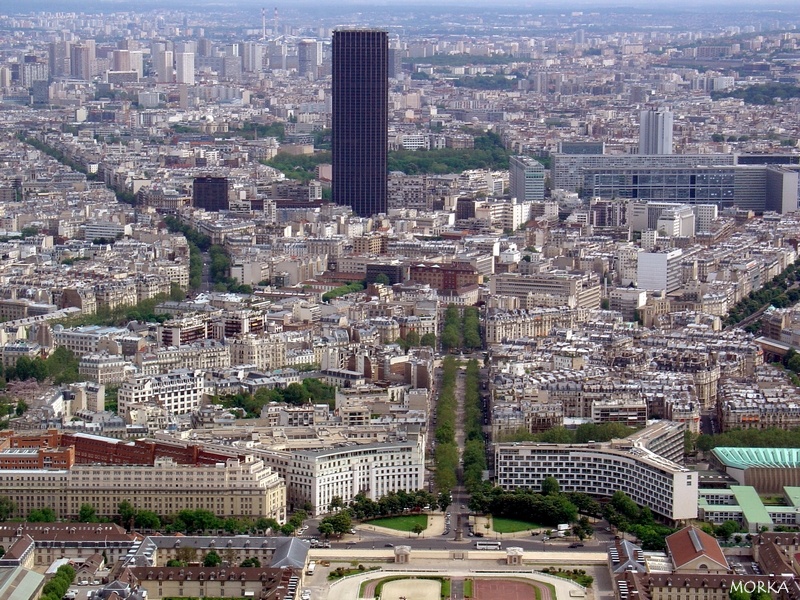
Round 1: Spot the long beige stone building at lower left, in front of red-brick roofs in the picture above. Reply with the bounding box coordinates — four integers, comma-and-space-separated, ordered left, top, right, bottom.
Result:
0, 456, 286, 522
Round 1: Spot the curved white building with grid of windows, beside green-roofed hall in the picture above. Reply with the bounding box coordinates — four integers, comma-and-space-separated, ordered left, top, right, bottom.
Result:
495, 442, 698, 522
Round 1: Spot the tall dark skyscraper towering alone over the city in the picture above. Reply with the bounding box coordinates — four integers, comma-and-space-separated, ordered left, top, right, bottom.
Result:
332, 29, 389, 217
